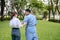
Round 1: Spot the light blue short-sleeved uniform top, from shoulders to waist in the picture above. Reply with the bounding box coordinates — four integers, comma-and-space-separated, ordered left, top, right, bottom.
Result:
23, 14, 36, 28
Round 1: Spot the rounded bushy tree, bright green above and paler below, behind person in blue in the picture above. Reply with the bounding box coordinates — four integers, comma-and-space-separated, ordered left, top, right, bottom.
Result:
30, 0, 45, 14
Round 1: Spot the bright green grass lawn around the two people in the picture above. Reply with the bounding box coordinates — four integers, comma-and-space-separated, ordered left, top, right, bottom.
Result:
0, 20, 60, 40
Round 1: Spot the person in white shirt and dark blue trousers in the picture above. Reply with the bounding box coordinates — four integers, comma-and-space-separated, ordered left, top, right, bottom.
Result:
10, 12, 21, 40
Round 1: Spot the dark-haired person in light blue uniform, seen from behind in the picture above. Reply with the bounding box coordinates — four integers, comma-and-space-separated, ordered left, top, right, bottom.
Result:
22, 9, 38, 40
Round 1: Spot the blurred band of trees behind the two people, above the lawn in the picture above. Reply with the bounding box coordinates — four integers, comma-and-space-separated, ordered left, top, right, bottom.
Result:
0, 0, 60, 22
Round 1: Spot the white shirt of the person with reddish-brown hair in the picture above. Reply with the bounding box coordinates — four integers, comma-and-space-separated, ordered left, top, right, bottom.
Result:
10, 17, 22, 28
